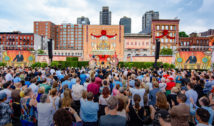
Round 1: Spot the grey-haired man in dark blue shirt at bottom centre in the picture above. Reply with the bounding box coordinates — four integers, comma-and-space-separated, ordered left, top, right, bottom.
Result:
99, 96, 126, 126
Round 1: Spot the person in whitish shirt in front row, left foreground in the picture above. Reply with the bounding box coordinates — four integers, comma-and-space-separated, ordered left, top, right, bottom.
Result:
37, 94, 56, 126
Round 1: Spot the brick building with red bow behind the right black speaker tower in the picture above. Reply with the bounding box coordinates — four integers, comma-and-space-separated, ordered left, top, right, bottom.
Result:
151, 19, 180, 55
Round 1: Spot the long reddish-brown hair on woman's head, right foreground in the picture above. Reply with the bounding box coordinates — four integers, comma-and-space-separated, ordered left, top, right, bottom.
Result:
156, 92, 169, 109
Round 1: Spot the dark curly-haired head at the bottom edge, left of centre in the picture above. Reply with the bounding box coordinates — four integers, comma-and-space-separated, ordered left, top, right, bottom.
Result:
53, 109, 74, 126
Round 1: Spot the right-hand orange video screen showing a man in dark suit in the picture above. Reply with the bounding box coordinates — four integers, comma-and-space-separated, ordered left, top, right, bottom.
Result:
175, 51, 211, 69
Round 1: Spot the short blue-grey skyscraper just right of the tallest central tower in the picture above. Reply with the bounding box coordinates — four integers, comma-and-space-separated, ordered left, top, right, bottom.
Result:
119, 16, 131, 33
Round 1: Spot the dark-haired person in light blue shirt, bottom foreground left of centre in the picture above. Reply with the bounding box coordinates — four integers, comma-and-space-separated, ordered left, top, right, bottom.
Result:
80, 92, 99, 126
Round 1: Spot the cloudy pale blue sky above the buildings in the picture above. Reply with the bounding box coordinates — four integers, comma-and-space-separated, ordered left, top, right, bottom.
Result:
0, 0, 214, 33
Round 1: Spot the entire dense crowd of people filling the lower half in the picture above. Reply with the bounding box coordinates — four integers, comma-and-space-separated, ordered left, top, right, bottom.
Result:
0, 66, 214, 126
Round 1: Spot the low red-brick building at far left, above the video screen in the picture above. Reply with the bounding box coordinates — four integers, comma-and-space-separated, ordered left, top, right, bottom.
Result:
0, 32, 34, 50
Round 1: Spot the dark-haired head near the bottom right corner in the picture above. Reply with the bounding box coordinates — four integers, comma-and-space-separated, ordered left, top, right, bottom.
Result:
196, 108, 210, 123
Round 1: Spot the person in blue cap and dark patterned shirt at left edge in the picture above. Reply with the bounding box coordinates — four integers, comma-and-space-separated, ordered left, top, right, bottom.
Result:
0, 92, 13, 126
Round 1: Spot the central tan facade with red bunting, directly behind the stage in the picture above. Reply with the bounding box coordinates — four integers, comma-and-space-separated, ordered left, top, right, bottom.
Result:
83, 25, 124, 65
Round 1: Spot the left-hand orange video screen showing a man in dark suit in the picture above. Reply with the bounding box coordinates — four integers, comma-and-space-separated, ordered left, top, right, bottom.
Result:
2, 50, 35, 66
